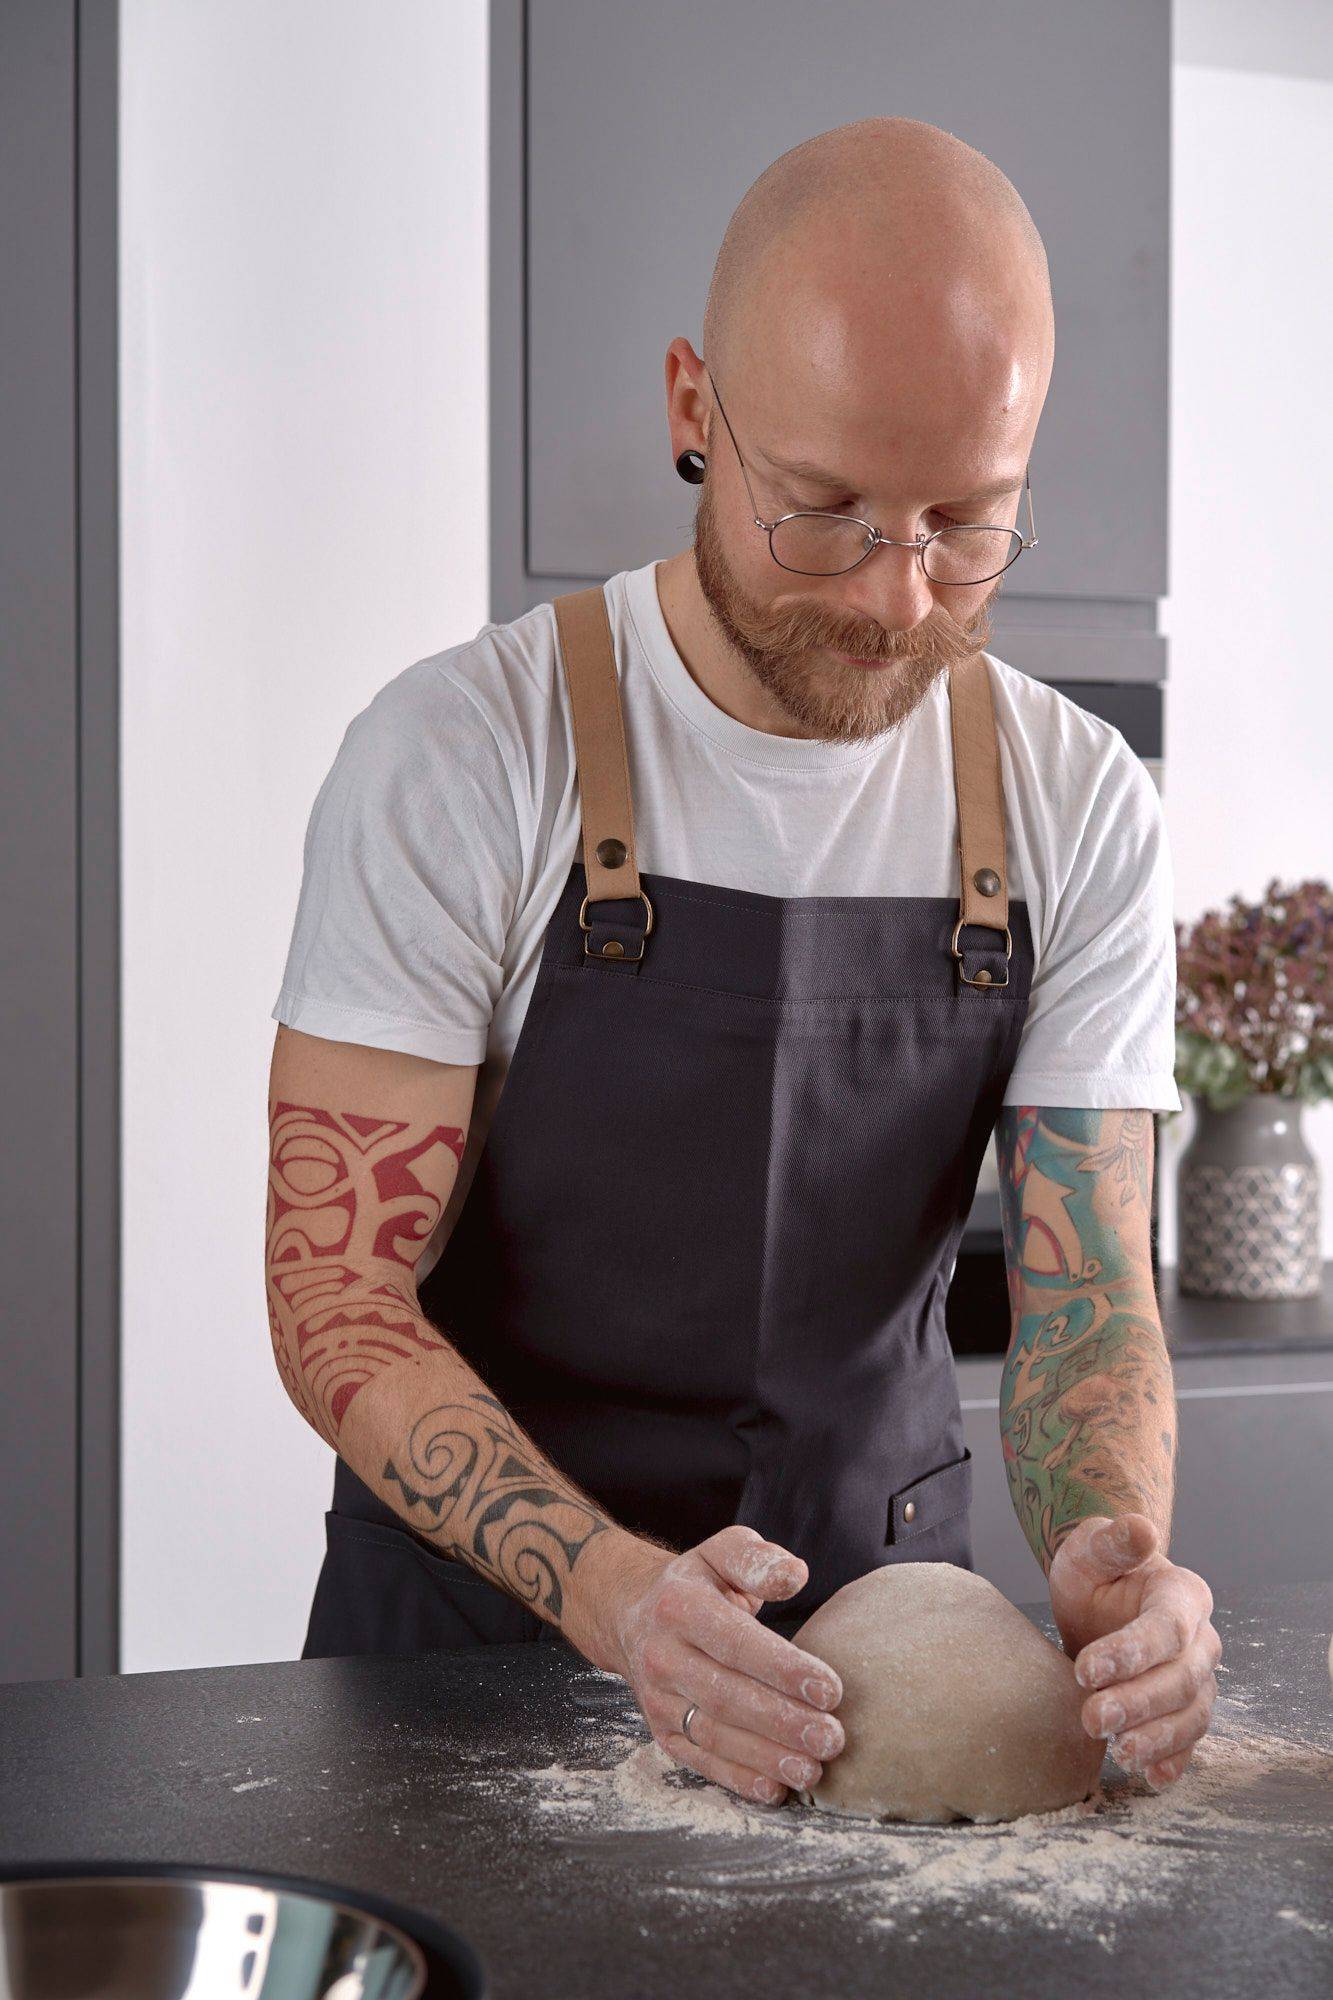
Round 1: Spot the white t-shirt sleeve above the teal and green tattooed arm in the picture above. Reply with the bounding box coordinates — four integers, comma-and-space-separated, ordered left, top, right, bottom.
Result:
1005, 738, 1181, 1112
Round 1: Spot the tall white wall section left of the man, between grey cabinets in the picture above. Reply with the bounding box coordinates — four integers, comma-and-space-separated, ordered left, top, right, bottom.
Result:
120, 0, 488, 1670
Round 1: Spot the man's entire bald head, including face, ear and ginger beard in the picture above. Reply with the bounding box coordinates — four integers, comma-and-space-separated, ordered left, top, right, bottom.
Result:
658, 118, 1055, 740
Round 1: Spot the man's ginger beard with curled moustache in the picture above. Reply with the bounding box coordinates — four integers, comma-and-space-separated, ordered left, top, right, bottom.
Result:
695, 476, 1003, 742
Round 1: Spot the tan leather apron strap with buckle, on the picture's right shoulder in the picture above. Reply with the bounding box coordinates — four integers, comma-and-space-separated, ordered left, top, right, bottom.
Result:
949, 652, 1013, 992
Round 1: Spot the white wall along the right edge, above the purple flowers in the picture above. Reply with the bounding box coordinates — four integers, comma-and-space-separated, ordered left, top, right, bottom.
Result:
1161, 27, 1333, 1262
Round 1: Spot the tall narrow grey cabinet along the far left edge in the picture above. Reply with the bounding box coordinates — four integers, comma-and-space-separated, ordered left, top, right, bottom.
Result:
0, 0, 122, 1682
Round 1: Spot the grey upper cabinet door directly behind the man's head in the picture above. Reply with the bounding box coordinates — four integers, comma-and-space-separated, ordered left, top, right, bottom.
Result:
520, 0, 1171, 644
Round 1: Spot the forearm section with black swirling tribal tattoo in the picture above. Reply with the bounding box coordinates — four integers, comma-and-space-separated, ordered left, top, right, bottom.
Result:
382, 1394, 614, 1622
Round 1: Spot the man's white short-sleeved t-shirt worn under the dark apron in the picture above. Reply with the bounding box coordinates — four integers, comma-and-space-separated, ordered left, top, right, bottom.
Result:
272, 562, 1181, 1168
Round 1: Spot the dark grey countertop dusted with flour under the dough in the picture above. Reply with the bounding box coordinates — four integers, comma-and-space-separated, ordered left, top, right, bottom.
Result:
0, 1584, 1333, 2000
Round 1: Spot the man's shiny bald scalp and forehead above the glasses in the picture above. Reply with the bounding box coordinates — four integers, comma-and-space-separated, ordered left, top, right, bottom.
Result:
703, 118, 1055, 472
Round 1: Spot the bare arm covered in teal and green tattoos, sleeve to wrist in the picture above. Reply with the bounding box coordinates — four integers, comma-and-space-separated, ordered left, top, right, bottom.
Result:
997, 1104, 1175, 1570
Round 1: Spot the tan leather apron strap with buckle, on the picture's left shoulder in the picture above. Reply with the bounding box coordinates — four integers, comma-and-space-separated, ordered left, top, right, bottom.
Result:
554, 586, 652, 964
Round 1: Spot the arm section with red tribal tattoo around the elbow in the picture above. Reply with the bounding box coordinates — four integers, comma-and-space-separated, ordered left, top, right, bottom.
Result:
266, 1104, 462, 1444
